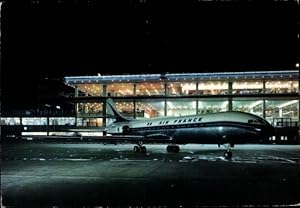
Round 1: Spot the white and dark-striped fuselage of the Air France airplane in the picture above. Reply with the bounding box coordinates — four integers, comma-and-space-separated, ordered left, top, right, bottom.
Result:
107, 112, 273, 144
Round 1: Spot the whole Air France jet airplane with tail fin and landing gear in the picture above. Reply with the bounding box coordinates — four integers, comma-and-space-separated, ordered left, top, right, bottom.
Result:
106, 98, 274, 159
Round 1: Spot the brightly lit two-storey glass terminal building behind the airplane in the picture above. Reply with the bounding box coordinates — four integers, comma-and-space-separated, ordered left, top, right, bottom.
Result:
65, 70, 299, 126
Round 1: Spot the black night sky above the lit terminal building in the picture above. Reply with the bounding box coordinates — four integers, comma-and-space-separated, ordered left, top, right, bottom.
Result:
1, 0, 299, 110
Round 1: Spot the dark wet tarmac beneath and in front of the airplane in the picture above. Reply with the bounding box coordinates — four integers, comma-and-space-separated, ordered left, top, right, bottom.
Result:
1, 142, 300, 207
